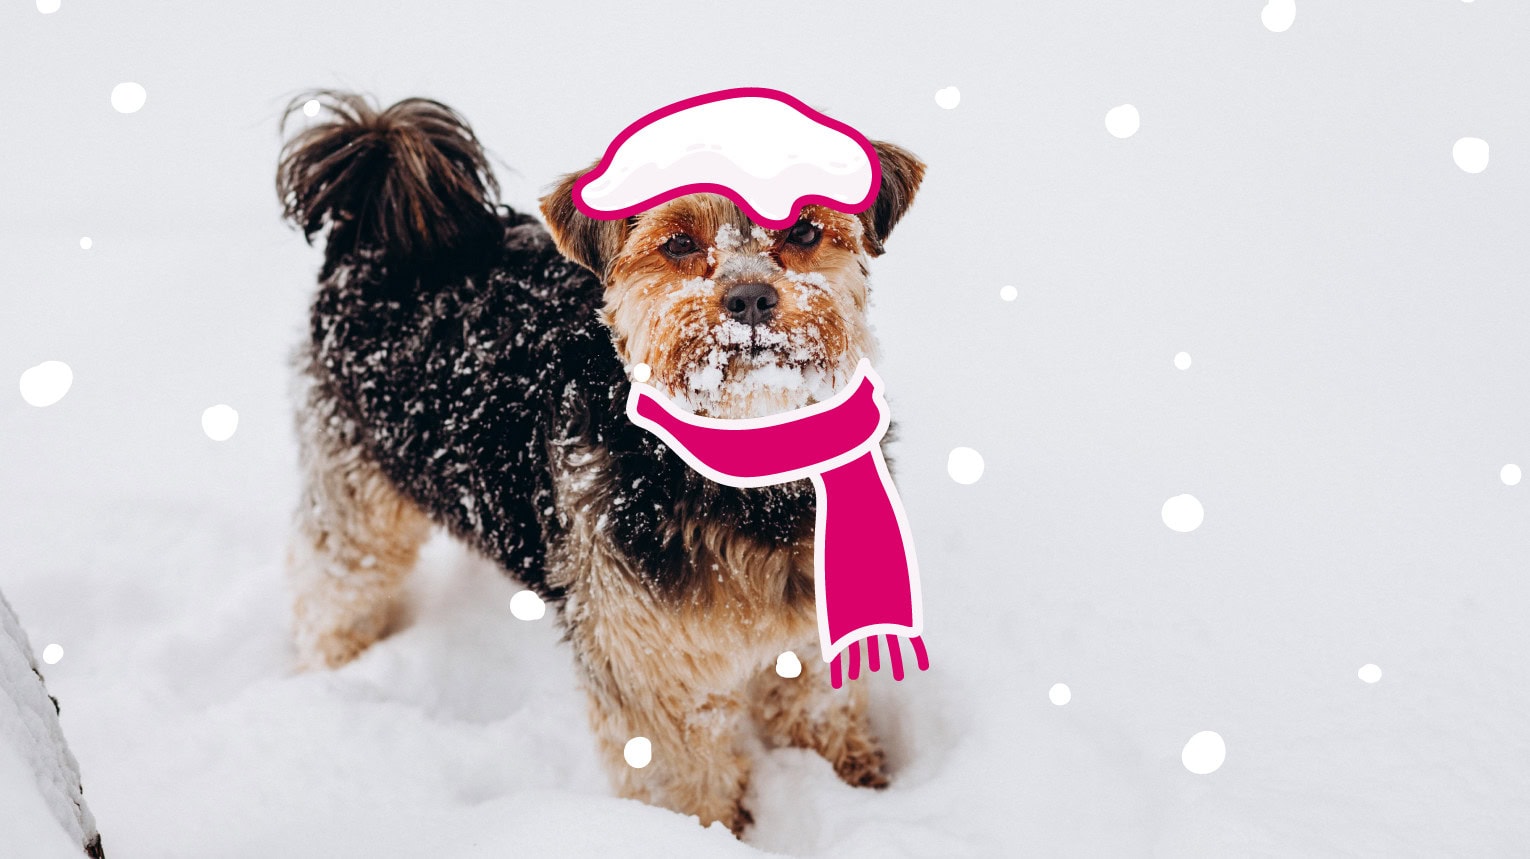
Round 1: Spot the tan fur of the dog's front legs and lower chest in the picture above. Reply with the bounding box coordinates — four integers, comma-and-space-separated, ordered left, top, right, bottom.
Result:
551, 434, 886, 831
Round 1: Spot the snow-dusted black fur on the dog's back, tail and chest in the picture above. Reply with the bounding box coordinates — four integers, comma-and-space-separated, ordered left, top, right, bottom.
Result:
278, 95, 814, 600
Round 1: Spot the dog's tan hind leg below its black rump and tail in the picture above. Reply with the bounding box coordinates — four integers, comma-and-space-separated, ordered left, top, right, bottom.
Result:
286, 369, 430, 668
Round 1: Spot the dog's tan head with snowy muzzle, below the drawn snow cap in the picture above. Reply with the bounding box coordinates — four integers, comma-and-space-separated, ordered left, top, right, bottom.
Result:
542, 142, 924, 418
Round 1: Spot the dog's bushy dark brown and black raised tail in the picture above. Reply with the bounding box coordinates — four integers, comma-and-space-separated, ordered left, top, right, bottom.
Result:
277, 90, 503, 266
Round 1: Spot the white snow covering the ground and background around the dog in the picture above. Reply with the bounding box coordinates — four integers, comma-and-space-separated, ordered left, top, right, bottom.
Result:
0, 0, 1530, 859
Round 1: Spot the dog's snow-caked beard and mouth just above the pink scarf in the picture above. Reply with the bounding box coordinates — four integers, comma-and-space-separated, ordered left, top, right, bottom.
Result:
670, 317, 855, 418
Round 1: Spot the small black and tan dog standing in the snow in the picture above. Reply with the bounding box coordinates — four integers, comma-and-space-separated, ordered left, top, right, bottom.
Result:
277, 90, 924, 835
